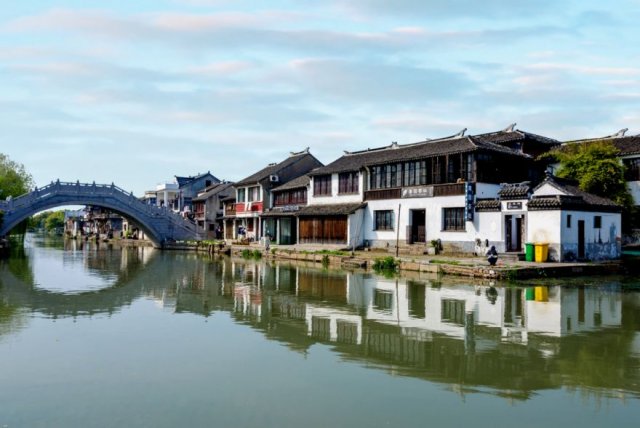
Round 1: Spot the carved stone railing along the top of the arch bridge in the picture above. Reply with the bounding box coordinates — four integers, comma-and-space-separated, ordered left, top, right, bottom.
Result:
0, 180, 200, 236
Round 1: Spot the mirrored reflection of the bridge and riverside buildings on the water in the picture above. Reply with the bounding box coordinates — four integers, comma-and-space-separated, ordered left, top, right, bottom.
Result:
0, 241, 640, 399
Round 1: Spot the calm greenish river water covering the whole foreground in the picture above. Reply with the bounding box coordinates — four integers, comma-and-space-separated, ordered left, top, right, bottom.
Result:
0, 235, 640, 428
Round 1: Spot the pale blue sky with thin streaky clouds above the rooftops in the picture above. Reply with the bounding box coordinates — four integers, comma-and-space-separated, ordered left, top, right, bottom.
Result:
0, 0, 640, 195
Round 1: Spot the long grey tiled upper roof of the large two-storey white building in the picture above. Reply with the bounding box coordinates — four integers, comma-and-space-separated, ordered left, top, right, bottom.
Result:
309, 131, 543, 175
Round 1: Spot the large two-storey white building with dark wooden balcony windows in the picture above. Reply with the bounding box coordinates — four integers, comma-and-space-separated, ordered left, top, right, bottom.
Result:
300, 126, 560, 253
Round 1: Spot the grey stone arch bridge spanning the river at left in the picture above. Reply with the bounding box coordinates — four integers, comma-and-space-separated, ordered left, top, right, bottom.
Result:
0, 180, 199, 248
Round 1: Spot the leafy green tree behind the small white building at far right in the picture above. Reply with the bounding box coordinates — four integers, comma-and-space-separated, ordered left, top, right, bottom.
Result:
544, 141, 633, 210
